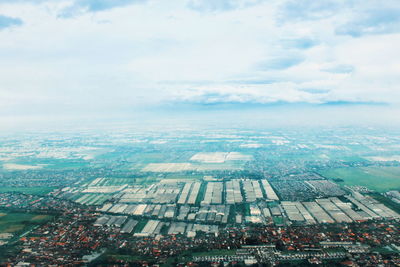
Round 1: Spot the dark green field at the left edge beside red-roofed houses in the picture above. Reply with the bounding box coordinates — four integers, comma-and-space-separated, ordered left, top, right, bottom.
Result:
0, 210, 52, 233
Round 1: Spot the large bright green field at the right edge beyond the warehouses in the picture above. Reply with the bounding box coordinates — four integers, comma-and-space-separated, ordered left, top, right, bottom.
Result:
319, 167, 400, 192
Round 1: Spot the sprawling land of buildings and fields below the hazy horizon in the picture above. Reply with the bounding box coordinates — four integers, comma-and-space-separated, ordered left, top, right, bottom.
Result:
0, 128, 400, 266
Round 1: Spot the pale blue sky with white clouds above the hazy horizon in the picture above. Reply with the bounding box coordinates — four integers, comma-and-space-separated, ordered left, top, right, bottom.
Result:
0, 0, 400, 129
